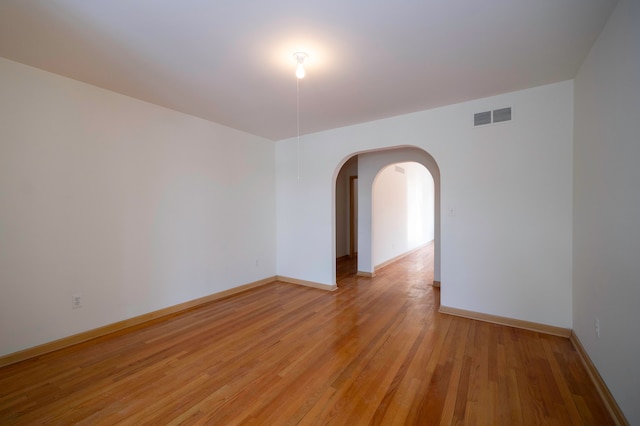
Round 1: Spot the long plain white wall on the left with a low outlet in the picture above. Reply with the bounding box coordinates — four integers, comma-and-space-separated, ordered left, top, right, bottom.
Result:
0, 59, 275, 355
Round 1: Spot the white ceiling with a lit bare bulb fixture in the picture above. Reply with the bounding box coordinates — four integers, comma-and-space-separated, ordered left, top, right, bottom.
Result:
0, 0, 616, 140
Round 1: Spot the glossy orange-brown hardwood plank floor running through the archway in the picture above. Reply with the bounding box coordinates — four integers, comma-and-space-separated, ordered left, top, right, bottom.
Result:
0, 246, 613, 425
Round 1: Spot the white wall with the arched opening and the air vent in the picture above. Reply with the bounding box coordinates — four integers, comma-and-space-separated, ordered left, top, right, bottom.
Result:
276, 81, 573, 327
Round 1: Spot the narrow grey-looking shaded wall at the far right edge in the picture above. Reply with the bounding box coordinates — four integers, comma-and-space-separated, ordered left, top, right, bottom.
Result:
573, 0, 640, 424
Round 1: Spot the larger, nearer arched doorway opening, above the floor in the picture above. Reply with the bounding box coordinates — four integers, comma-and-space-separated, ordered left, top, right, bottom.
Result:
334, 147, 440, 286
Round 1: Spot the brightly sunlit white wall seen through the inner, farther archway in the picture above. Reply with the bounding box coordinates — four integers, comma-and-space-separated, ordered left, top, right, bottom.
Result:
372, 162, 435, 266
